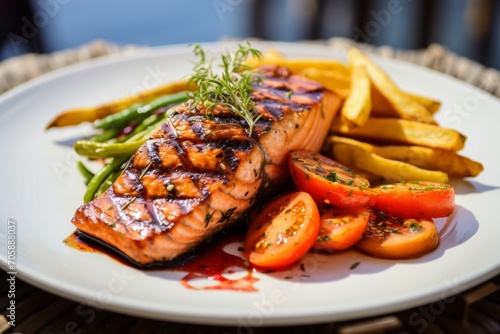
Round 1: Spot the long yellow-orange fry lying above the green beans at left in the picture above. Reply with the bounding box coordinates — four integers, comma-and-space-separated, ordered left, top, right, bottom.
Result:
47, 80, 196, 129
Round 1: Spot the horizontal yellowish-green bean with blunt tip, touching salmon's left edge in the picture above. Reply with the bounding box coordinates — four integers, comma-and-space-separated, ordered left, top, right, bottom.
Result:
73, 140, 144, 159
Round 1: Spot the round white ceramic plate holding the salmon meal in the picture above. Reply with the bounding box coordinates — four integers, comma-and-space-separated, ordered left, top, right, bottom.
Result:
0, 43, 500, 330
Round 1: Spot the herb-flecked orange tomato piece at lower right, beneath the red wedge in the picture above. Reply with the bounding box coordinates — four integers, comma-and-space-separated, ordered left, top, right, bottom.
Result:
355, 210, 439, 259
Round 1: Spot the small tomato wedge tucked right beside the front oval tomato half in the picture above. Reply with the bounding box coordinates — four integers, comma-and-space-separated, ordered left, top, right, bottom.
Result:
312, 205, 370, 253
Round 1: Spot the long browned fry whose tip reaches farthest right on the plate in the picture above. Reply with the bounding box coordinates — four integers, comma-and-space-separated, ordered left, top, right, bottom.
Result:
325, 136, 484, 178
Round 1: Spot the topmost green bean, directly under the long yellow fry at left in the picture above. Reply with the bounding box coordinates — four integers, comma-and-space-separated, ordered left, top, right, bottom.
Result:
94, 92, 187, 129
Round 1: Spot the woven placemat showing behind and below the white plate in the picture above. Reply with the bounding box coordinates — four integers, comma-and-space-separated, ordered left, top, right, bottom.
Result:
0, 38, 500, 334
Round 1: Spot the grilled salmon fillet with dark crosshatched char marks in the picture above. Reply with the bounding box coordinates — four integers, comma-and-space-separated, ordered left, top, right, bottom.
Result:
72, 66, 340, 267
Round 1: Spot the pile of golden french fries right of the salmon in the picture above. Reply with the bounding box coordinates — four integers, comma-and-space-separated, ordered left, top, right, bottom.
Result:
248, 48, 483, 183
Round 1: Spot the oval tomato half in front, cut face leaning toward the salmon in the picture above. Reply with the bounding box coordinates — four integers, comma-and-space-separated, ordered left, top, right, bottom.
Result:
244, 191, 320, 269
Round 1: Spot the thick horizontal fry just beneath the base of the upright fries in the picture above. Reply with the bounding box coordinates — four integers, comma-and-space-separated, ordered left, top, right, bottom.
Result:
330, 117, 466, 151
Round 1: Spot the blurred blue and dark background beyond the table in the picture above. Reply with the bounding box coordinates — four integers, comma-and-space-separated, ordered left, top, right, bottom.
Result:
0, 0, 500, 69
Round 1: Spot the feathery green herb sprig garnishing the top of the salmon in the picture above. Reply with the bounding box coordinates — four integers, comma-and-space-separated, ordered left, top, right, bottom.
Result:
188, 42, 261, 134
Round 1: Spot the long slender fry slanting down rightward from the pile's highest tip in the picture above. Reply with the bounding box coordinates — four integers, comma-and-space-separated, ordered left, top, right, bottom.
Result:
349, 48, 436, 124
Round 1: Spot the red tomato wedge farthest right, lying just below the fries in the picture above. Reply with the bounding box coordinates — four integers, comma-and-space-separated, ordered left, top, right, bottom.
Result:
373, 181, 455, 218
